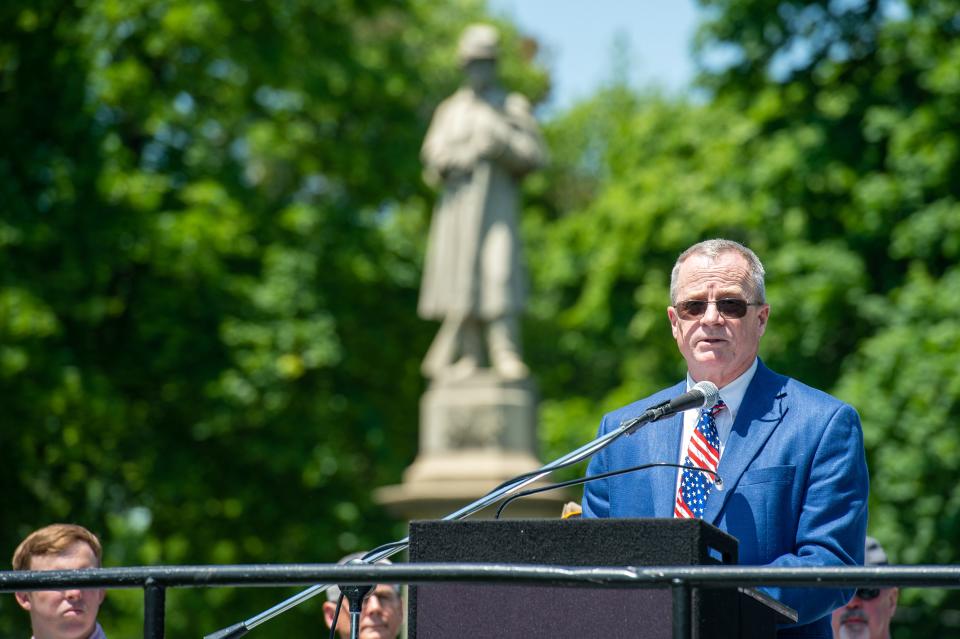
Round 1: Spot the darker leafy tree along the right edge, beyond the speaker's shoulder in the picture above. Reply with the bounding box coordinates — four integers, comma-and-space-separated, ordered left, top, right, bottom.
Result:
703, 1, 960, 637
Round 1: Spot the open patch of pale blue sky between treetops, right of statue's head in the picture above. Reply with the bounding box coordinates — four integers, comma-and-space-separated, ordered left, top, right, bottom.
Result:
488, 0, 697, 109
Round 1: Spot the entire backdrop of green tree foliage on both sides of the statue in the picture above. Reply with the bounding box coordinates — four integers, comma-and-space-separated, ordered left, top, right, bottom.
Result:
0, 0, 960, 637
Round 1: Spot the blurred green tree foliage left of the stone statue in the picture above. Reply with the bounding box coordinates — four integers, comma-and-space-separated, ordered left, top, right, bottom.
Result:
0, 0, 546, 637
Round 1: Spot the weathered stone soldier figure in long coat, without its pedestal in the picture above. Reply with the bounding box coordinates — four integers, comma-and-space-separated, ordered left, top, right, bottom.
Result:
418, 24, 546, 380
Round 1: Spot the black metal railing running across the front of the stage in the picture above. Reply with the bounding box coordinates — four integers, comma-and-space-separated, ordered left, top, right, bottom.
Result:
0, 563, 960, 639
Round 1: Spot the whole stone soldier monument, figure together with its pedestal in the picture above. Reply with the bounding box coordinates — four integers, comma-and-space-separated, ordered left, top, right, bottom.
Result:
375, 25, 570, 519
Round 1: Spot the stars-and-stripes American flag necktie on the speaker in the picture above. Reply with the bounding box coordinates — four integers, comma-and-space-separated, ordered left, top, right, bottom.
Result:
673, 400, 726, 519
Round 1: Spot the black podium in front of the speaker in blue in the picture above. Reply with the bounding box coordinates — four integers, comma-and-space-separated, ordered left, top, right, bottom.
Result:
408, 519, 795, 639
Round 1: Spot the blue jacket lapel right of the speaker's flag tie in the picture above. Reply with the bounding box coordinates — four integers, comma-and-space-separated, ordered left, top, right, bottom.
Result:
704, 362, 788, 524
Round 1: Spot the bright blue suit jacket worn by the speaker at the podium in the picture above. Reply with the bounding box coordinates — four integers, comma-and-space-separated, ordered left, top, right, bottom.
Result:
583, 362, 868, 638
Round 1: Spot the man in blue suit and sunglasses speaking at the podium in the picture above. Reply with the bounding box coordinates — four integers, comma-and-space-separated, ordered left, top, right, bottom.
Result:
583, 240, 868, 639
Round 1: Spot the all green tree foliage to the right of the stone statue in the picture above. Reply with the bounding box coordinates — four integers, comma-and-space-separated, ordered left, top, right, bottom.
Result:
527, 0, 960, 637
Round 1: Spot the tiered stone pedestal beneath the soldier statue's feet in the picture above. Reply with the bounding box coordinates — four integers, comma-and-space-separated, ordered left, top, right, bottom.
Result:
374, 371, 569, 519
